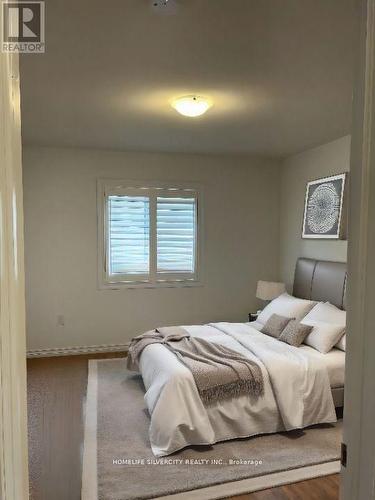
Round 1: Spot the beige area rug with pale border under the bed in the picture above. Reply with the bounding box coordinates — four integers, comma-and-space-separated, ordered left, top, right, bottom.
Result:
82, 359, 342, 500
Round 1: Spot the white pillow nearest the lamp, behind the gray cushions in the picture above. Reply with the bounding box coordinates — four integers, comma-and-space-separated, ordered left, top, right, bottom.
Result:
257, 293, 316, 325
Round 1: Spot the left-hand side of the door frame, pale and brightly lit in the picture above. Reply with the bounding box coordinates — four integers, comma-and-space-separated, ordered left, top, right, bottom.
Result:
0, 47, 29, 500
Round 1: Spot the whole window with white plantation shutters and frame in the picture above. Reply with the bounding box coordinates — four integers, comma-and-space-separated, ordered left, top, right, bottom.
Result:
98, 181, 201, 288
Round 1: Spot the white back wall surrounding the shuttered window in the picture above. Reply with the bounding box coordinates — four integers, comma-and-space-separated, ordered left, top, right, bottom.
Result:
23, 148, 282, 349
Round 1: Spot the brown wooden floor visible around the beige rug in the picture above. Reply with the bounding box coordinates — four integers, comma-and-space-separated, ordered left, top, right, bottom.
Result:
28, 353, 339, 500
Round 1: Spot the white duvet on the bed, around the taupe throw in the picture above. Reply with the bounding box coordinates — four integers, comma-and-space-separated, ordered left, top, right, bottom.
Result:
139, 323, 336, 456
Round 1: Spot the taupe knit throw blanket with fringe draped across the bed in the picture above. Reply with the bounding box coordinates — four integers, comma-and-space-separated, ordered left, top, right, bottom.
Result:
127, 326, 264, 404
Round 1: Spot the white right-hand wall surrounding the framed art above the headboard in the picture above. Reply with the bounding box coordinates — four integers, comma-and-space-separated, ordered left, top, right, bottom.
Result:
280, 136, 350, 289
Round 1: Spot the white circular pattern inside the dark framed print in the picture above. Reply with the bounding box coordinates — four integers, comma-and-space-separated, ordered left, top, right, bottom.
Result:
307, 182, 340, 234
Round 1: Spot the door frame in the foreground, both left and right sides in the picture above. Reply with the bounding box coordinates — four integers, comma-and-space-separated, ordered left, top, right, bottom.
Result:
0, 0, 375, 500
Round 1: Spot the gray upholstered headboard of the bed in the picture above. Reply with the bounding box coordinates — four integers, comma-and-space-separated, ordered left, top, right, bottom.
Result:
293, 258, 347, 309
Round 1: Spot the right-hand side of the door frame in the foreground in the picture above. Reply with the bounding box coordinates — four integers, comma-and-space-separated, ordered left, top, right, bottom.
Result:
341, 0, 375, 500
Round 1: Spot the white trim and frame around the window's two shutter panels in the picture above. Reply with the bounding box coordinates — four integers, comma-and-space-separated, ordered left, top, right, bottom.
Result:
97, 179, 203, 290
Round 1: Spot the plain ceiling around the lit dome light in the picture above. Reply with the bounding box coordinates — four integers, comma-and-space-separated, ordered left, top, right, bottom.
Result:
21, 0, 357, 157
